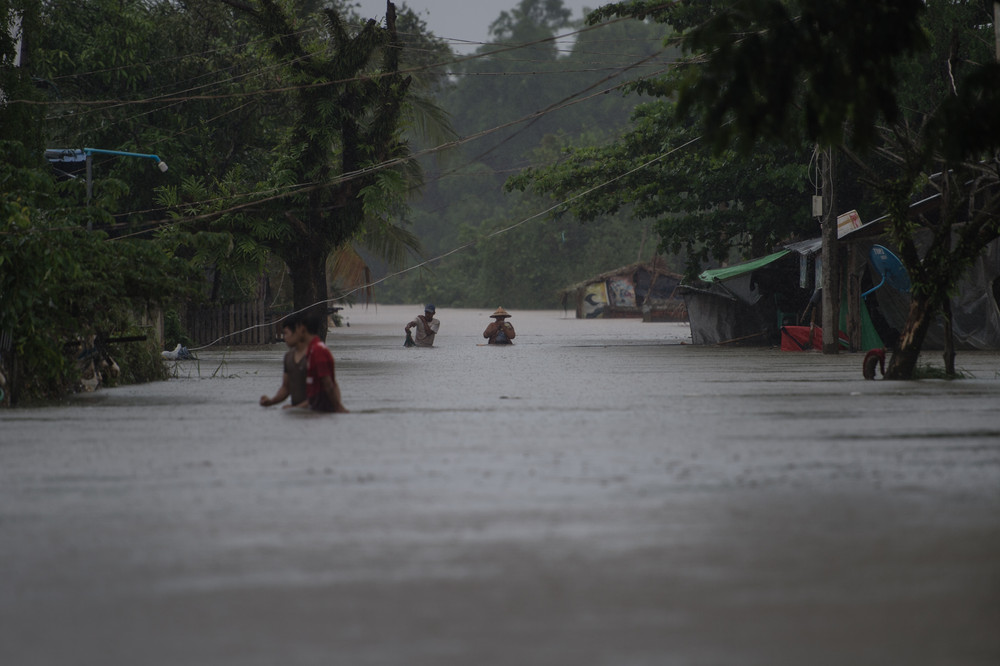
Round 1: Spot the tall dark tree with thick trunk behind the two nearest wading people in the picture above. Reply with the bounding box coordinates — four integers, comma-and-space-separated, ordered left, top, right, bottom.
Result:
205, 0, 420, 332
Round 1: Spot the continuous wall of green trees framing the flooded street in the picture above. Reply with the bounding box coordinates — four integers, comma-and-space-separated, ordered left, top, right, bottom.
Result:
9, 0, 1000, 400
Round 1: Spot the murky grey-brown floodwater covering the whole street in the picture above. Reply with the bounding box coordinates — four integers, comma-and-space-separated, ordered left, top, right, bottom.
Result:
0, 306, 1000, 666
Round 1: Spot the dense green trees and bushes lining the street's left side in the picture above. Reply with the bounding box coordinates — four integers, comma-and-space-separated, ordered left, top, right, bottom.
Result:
0, 0, 440, 396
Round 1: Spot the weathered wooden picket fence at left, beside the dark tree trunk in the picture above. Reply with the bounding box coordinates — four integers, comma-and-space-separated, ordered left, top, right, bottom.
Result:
185, 299, 278, 347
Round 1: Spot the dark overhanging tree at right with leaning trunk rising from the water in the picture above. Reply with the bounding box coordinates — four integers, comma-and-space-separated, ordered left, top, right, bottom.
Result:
576, 0, 1000, 378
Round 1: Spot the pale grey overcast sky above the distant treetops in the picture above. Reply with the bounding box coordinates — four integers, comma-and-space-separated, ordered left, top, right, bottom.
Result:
355, 0, 596, 53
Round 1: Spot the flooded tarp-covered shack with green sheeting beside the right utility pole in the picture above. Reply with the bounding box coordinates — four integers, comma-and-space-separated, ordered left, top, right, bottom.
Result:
677, 209, 1000, 351
